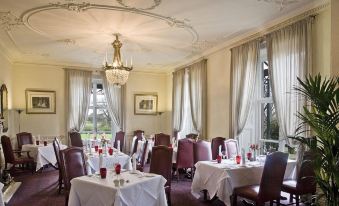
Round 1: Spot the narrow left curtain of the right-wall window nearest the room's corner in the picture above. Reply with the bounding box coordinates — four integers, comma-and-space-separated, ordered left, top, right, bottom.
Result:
172, 69, 185, 137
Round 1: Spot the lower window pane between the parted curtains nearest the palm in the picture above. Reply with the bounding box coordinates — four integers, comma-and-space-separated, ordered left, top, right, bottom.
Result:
261, 103, 279, 140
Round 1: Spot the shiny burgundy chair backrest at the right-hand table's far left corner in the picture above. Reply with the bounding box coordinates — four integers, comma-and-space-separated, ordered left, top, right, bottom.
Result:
193, 140, 212, 164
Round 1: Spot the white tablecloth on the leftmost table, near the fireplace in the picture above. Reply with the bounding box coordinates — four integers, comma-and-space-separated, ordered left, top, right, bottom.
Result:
21, 144, 67, 171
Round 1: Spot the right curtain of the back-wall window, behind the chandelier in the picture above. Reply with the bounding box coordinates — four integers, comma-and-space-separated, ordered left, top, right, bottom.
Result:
101, 72, 125, 138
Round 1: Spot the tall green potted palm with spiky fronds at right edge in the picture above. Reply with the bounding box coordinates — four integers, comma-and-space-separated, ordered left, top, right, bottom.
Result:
291, 75, 339, 206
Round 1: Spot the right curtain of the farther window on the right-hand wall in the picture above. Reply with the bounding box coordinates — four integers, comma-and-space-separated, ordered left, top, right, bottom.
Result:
188, 59, 207, 138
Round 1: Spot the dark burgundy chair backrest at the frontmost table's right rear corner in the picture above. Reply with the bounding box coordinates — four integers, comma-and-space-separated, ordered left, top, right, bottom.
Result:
150, 145, 173, 186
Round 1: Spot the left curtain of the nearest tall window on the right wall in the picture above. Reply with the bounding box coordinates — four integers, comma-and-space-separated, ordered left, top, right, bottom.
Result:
230, 40, 260, 138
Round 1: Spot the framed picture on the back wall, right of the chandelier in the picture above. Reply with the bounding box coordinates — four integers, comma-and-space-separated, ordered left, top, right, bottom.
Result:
134, 94, 158, 115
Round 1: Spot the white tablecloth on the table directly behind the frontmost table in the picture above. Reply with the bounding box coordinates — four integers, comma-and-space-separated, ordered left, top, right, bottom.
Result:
86, 151, 132, 174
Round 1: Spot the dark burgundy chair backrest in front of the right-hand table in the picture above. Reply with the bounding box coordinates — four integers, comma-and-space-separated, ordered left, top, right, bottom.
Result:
258, 152, 288, 202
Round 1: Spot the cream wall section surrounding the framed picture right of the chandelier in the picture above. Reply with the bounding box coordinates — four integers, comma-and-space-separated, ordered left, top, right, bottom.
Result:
126, 72, 172, 135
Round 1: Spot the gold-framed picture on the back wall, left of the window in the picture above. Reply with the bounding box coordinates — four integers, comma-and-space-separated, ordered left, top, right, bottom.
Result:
26, 89, 56, 114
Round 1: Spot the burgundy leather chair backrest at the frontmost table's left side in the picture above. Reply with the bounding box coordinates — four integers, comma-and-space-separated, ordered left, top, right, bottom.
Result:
59, 147, 87, 191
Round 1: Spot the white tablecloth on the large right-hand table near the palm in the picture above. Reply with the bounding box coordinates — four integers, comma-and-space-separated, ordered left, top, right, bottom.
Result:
191, 160, 296, 205
